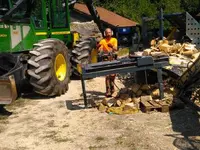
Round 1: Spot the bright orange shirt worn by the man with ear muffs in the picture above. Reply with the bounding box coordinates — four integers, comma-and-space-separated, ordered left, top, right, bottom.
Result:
99, 38, 117, 52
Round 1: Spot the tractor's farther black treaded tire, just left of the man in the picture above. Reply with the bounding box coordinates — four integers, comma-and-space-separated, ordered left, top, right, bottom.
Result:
72, 37, 96, 64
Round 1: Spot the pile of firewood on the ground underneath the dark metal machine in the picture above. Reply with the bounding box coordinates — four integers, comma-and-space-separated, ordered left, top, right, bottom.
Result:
97, 83, 179, 114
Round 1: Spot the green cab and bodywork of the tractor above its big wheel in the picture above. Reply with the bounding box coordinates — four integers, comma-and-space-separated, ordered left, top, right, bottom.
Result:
0, 0, 71, 52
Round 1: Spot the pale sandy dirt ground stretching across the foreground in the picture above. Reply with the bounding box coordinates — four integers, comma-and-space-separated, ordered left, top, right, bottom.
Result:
0, 78, 200, 150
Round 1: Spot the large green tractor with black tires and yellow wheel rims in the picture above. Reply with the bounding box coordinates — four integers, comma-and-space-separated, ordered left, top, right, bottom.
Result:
0, 0, 98, 104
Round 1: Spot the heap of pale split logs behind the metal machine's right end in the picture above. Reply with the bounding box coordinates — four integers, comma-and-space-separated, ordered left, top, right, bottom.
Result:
142, 39, 200, 76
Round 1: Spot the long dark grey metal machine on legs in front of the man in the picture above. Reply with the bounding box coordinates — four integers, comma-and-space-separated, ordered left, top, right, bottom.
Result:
81, 57, 169, 107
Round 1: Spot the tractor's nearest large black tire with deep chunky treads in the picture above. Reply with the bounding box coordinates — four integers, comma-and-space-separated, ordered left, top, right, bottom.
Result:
27, 39, 71, 96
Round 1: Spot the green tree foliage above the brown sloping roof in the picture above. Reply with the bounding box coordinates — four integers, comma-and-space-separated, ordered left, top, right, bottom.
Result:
97, 0, 200, 23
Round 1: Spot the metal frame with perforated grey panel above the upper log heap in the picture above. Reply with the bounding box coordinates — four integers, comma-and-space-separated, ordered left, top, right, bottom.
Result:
142, 8, 200, 48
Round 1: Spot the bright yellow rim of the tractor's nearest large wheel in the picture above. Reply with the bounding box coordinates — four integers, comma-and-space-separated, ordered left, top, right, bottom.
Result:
54, 54, 67, 81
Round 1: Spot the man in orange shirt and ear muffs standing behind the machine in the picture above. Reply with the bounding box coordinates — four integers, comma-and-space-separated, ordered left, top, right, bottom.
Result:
97, 28, 118, 97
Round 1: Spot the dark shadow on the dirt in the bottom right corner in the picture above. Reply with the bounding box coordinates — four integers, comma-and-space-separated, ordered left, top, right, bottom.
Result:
166, 107, 200, 150
